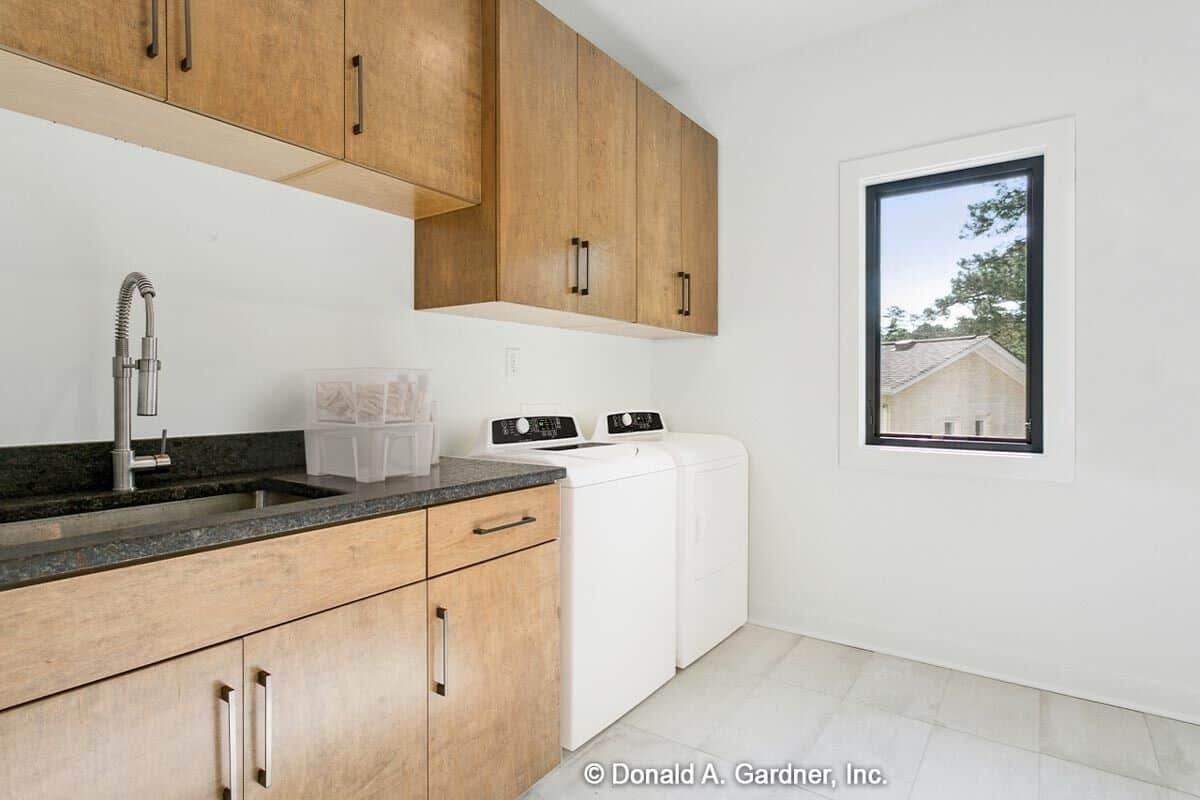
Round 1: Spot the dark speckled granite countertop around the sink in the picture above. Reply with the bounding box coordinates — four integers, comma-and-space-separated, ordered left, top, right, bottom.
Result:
0, 458, 566, 590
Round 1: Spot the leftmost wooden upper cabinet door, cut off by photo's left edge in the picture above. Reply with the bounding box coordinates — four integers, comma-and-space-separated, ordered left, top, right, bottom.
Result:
0, 0, 167, 100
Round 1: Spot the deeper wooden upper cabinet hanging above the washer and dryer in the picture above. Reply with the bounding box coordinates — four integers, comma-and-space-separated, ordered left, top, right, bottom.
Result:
415, 0, 716, 337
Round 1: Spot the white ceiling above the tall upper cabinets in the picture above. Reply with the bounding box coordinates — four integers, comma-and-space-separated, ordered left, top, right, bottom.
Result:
539, 0, 940, 89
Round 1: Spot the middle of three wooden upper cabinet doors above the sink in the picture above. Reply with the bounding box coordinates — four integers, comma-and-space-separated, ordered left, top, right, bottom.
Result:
167, 0, 346, 158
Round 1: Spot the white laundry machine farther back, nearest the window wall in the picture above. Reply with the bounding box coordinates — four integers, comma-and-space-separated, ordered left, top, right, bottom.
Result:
592, 411, 749, 667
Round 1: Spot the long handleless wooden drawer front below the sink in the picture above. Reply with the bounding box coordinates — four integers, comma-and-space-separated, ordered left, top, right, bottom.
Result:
0, 511, 425, 709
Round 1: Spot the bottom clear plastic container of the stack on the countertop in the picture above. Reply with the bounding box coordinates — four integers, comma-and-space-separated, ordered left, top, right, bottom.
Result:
304, 422, 434, 483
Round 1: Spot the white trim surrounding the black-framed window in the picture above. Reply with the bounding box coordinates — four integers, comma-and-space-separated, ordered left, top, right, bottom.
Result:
839, 118, 1075, 481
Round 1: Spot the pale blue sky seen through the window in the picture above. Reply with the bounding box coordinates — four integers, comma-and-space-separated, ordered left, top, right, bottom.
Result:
880, 178, 1025, 324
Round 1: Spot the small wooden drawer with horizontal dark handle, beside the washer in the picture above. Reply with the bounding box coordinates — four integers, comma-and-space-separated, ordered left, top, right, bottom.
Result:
428, 485, 558, 576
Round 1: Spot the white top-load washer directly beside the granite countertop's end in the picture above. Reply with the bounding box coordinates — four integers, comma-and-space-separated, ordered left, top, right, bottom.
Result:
473, 416, 676, 750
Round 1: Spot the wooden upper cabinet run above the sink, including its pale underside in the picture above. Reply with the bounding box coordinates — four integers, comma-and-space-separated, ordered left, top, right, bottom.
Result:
0, 0, 482, 218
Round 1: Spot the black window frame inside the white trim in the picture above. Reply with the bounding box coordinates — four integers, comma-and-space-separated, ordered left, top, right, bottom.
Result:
865, 156, 1045, 453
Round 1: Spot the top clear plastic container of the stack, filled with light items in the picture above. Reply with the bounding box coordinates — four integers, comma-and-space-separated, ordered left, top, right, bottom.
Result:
305, 367, 433, 428
